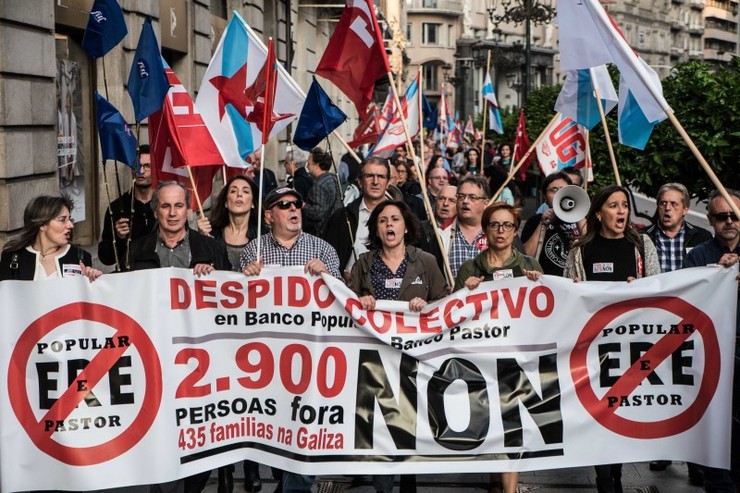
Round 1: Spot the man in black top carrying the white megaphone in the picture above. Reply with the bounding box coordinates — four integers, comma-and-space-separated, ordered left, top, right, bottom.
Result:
522, 171, 586, 277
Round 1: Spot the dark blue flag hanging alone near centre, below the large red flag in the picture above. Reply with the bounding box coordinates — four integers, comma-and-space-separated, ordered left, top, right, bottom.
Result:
293, 77, 347, 151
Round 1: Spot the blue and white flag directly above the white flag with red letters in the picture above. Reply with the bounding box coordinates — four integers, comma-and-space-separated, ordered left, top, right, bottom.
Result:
555, 65, 618, 130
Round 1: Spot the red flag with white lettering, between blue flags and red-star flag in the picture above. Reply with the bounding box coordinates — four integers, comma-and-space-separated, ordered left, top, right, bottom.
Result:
149, 67, 224, 210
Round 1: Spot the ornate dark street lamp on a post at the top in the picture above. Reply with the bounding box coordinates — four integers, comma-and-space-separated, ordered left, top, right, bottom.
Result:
487, 0, 555, 105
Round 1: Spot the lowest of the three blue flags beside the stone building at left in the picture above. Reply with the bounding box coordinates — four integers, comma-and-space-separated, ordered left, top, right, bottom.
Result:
95, 91, 136, 169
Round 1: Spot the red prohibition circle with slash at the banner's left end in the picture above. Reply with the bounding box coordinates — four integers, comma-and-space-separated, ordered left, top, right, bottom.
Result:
8, 302, 162, 466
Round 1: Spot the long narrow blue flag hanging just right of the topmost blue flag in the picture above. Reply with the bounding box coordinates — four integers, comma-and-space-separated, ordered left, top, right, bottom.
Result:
128, 17, 170, 122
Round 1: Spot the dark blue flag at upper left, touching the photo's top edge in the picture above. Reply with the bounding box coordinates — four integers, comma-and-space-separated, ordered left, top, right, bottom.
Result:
82, 0, 128, 58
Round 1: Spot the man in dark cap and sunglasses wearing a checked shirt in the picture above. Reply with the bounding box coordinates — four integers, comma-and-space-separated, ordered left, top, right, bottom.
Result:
240, 187, 340, 493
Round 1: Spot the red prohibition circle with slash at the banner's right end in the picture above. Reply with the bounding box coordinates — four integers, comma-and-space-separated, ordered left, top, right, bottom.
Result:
570, 296, 720, 438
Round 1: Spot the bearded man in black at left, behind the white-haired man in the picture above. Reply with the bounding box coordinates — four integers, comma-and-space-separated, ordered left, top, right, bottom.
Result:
98, 145, 156, 271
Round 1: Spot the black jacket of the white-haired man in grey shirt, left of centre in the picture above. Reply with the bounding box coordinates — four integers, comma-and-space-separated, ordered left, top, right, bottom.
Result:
131, 228, 231, 270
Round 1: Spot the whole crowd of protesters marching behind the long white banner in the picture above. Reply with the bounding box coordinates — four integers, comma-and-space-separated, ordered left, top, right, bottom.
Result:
0, 135, 740, 493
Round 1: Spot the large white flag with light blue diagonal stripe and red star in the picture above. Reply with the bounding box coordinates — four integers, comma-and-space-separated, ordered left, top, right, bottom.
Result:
195, 12, 306, 168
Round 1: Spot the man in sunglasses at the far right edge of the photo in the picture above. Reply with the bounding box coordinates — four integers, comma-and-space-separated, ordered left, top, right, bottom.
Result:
683, 186, 740, 493
